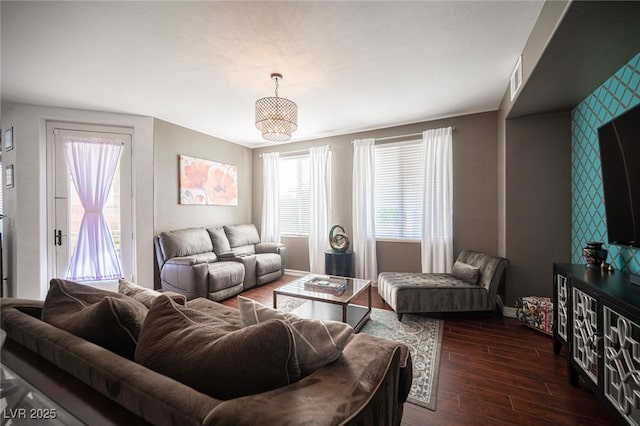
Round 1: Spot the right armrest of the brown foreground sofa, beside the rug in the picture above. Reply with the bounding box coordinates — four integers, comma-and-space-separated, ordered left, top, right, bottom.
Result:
204, 334, 411, 425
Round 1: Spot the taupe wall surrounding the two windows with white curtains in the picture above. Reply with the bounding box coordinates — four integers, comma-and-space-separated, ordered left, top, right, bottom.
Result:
252, 112, 498, 272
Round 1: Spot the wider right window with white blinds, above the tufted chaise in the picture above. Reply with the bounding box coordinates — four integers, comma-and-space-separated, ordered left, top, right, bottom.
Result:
375, 140, 424, 240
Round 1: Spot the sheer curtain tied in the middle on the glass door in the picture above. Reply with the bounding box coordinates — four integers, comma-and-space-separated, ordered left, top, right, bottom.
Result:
64, 138, 122, 281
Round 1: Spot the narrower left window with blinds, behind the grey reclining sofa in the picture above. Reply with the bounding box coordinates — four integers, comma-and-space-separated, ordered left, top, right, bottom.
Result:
280, 154, 309, 235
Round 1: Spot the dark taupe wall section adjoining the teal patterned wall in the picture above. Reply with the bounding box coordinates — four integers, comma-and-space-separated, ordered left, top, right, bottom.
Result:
505, 111, 571, 306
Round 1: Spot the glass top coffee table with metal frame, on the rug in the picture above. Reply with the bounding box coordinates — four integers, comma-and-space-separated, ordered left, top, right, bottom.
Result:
273, 274, 371, 332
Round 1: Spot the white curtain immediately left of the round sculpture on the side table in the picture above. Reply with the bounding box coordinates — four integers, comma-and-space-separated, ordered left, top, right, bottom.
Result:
309, 145, 331, 274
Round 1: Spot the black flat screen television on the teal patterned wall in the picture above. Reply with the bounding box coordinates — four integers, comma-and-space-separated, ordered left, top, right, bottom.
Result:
598, 105, 640, 247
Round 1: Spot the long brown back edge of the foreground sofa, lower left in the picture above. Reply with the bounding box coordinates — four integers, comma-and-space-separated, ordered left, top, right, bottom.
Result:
0, 299, 220, 425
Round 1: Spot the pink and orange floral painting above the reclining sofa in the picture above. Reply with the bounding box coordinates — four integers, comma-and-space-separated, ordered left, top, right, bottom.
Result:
180, 155, 238, 206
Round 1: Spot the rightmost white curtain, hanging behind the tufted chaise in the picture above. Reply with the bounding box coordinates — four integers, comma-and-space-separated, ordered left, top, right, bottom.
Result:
422, 127, 453, 273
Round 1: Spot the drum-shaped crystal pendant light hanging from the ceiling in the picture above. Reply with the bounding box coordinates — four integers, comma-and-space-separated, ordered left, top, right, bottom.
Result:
256, 73, 298, 142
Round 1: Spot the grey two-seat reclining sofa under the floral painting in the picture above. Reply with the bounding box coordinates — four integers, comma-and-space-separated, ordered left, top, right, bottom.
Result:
154, 224, 286, 301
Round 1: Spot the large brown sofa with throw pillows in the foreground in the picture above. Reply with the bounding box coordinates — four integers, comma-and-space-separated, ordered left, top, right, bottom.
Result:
0, 280, 412, 426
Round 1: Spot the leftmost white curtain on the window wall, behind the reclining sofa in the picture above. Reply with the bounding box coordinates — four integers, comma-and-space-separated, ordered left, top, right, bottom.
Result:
260, 152, 280, 243
